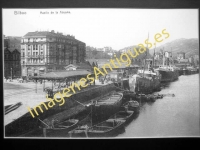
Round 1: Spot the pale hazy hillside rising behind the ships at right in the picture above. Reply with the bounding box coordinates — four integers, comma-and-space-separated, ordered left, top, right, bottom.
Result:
149, 38, 199, 58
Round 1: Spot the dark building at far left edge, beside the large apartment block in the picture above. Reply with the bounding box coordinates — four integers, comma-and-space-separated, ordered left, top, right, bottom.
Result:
4, 36, 21, 78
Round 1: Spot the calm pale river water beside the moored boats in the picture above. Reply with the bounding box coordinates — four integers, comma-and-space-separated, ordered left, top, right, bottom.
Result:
117, 74, 200, 138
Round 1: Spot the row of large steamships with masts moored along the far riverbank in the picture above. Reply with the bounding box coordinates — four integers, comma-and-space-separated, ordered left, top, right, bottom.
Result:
129, 56, 199, 94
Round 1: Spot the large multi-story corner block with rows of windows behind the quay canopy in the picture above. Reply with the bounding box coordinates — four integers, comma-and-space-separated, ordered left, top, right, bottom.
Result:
21, 30, 86, 76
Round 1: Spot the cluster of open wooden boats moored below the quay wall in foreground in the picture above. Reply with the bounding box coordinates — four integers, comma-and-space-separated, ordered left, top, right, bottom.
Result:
40, 91, 140, 137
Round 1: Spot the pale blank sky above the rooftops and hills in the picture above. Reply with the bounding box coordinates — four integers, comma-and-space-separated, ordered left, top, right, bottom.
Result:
2, 8, 199, 50
